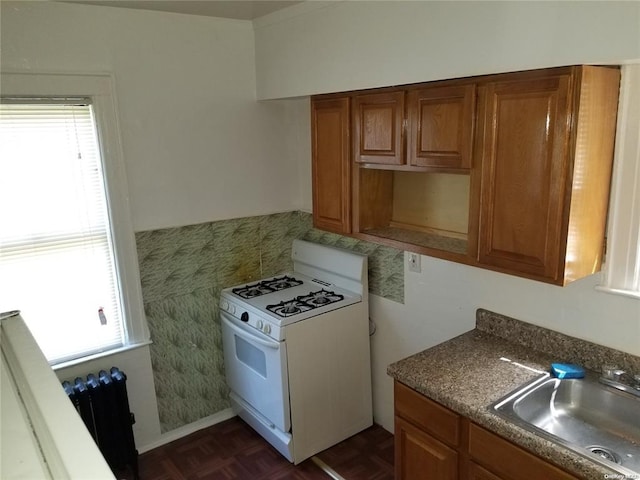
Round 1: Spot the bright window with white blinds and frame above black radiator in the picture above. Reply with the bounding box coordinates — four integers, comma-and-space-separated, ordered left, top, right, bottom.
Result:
0, 74, 148, 364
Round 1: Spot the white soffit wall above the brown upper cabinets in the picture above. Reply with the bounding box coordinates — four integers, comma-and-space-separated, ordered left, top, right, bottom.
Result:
254, 1, 640, 98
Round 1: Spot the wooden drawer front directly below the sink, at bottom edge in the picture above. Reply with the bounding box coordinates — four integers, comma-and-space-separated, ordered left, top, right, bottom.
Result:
469, 423, 577, 480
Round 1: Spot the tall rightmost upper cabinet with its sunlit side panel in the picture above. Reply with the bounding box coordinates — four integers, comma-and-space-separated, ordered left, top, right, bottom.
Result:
475, 66, 620, 285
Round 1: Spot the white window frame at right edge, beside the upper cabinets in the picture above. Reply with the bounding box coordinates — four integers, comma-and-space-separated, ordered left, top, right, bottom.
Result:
596, 63, 640, 299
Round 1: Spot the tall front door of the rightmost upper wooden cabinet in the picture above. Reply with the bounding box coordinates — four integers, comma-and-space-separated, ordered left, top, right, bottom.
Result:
476, 74, 571, 281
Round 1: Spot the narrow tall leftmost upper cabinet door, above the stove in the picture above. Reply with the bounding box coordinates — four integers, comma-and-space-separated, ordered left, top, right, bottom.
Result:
311, 97, 351, 233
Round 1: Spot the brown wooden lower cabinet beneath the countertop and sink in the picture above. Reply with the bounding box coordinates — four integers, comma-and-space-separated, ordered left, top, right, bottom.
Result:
394, 382, 579, 480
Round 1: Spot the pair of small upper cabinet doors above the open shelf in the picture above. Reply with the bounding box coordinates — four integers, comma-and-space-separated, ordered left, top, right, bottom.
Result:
353, 82, 476, 169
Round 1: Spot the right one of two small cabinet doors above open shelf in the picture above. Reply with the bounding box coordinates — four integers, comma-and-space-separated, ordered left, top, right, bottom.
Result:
407, 84, 476, 169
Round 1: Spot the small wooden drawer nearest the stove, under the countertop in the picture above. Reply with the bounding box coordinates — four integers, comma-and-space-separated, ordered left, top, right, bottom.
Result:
394, 382, 460, 447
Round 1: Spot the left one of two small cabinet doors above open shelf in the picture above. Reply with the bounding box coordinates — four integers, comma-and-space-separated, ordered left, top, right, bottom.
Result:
353, 91, 405, 165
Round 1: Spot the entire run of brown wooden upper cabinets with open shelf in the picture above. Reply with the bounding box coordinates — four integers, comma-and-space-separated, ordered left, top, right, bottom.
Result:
312, 66, 620, 285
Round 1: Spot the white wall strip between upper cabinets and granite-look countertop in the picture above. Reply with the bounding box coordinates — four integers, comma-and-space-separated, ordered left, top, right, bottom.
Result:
371, 254, 640, 431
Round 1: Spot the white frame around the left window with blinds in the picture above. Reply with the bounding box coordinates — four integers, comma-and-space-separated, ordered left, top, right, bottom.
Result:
0, 72, 151, 369
